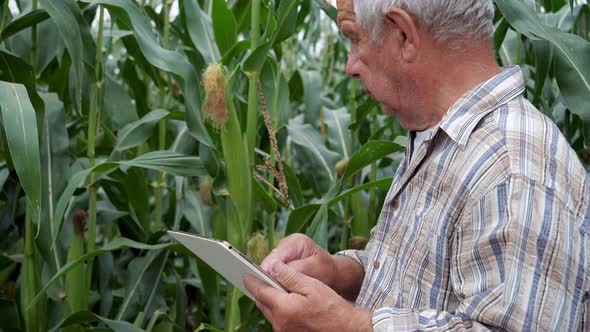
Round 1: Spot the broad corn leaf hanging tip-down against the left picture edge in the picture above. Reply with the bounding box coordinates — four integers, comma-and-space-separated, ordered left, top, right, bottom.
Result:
0, 81, 41, 221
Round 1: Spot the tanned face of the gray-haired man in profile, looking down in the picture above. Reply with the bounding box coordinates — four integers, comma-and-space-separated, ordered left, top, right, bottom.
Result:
338, 0, 416, 125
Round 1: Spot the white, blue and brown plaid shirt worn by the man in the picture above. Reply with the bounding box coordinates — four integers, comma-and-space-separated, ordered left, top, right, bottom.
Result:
339, 67, 590, 331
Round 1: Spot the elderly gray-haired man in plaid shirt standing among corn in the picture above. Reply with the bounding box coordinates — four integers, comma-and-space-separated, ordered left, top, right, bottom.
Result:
245, 0, 590, 332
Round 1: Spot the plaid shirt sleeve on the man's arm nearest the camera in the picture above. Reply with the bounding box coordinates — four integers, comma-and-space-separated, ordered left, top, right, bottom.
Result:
373, 176, 590, 332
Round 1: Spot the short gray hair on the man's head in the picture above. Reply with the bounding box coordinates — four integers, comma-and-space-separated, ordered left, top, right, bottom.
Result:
354, 0, 494, 42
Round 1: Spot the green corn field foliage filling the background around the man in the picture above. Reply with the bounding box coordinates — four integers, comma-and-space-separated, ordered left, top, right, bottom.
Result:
0, 0, 590, 332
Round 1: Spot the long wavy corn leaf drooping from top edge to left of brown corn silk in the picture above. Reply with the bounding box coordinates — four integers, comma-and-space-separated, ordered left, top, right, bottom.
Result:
83, 0, 214, 148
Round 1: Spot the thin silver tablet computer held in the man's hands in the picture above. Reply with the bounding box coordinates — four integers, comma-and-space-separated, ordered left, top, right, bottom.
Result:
168, 231, 288, 301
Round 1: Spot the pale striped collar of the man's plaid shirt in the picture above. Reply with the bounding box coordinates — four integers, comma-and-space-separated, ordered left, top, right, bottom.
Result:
439, 66, 525, 148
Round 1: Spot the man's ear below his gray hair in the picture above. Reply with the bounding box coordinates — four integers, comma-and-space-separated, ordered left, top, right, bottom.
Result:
383, 8, 421, 62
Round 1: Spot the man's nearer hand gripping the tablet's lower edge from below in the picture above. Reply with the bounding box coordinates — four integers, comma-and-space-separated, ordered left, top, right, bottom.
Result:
244, 259, 372, 332
